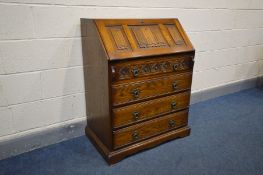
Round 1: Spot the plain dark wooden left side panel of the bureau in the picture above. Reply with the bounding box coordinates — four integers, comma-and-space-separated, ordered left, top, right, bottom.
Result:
81, 19, 112, 149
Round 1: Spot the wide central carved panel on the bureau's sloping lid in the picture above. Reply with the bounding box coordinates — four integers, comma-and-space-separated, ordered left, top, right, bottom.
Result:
130, 25, 168, 48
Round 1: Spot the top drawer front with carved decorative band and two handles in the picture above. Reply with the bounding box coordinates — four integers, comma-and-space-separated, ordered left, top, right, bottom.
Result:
111, 57, 193, 80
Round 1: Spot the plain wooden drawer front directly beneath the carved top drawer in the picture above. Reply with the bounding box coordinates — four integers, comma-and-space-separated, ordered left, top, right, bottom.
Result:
112, 73, 192, 106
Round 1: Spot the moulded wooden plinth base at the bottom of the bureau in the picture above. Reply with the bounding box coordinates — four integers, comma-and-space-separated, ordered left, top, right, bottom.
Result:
86, 127, 191, 165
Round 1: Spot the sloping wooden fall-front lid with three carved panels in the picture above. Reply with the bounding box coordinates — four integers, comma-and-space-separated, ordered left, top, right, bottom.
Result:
85, 19, 194, 60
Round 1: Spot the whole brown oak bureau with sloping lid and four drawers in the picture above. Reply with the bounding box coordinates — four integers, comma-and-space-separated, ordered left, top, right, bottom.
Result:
81, 19, 195, 164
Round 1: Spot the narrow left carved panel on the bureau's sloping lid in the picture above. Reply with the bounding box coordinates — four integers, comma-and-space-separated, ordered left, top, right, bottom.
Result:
108, 26, 130, 51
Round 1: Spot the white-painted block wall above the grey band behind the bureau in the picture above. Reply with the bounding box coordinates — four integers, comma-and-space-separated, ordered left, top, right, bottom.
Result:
0, 0, 263, 146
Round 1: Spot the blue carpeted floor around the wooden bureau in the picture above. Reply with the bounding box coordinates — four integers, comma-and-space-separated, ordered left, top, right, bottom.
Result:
0, 89, 263, 175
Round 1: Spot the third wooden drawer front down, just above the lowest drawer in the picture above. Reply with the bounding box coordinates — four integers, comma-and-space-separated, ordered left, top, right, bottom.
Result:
113, 91, 190, 128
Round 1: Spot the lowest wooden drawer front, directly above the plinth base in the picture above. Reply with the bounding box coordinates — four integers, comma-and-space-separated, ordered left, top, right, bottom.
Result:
113, 110, 188, 149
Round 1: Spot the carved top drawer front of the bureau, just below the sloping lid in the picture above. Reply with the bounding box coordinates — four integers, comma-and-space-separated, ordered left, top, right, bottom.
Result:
111, 55, 193, 82
